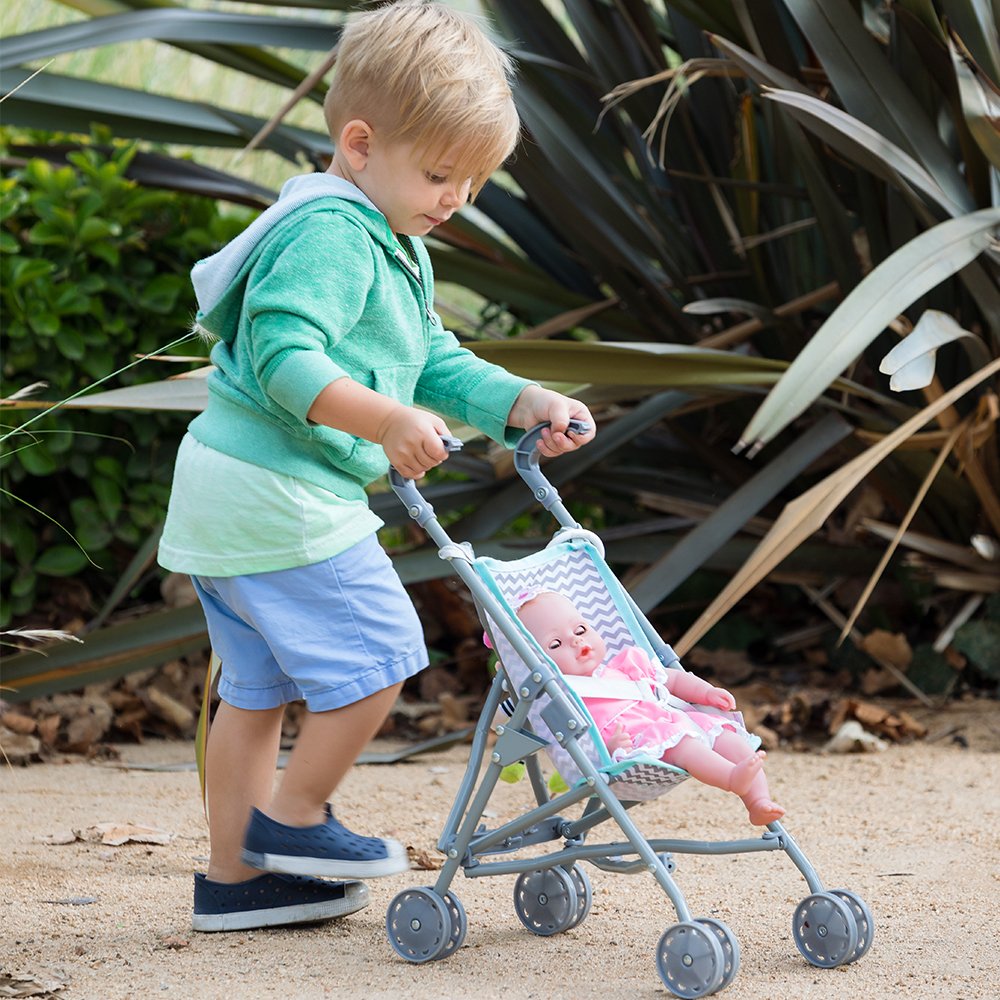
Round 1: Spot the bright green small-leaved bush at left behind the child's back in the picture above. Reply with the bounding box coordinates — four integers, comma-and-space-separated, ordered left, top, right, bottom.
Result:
0, 133, 245, 625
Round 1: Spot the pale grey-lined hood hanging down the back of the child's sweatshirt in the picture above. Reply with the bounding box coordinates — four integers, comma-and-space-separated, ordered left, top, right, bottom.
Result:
191, 173, 393, 342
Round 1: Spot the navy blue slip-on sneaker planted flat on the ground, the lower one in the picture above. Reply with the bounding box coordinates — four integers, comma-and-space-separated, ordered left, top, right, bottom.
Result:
191, 872, 369, 931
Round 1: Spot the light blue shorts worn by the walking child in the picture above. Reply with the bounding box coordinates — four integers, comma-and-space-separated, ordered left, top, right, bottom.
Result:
192, 535, 428, 712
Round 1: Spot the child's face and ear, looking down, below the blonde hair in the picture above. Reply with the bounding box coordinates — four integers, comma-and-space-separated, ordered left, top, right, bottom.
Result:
353, 133, 472, 236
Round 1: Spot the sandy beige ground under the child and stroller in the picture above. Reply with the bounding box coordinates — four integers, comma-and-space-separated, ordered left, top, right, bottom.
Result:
0, 702, 1000, 1000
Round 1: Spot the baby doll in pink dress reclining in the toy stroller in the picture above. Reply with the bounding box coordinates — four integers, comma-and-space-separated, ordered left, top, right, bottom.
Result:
517, 591, 785, 826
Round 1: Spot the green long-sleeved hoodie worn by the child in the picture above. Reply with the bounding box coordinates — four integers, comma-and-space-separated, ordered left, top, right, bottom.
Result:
190, 179, 531, 500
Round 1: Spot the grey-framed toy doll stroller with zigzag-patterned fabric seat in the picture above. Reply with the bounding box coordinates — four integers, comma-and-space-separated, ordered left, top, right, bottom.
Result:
386, 422, 874, 997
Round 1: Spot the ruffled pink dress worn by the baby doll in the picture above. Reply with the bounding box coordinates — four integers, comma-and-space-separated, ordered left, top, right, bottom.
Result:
583, 646, 760, 761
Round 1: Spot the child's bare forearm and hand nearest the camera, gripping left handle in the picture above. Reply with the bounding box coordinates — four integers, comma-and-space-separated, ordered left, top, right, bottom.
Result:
308, 378, 449, 479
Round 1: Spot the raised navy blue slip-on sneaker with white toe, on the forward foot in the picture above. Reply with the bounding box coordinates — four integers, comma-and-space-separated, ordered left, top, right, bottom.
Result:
243, 803, 410, 878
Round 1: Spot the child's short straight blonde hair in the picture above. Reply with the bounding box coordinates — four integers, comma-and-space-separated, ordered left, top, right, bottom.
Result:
323, 0, 520, 198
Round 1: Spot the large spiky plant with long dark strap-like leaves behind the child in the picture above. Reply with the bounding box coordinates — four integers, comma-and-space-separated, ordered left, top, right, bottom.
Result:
0, 0, 1000, 704
